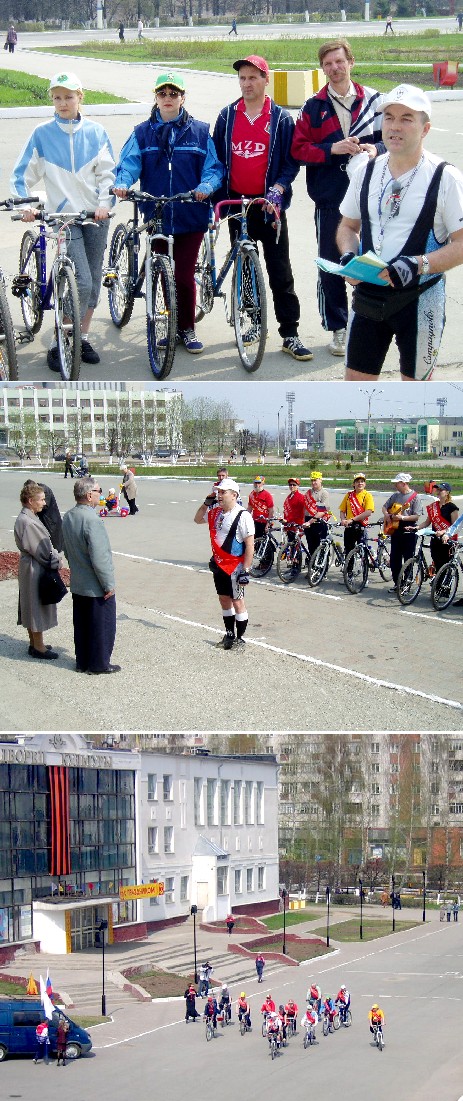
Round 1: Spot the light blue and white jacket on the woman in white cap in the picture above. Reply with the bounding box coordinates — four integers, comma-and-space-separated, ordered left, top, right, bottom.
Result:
10, 115, 115, 211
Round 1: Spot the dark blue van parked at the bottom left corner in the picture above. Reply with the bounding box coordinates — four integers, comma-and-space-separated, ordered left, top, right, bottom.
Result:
0, 994, 91, 1062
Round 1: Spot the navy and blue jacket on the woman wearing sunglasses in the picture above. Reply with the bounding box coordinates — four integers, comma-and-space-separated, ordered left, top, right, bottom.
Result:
115, 108, 223, 233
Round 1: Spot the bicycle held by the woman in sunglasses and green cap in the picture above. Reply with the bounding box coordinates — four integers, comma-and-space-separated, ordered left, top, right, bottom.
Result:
103, 188, 194, 379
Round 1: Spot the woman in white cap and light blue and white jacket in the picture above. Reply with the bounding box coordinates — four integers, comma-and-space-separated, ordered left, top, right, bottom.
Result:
11, 73, 114, 371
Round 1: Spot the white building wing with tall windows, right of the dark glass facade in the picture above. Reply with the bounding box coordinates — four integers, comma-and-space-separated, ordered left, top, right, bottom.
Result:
136, 752, 278, 924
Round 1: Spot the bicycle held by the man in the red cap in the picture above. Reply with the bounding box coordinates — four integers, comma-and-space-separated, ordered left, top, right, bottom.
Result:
195, 198, 280, 372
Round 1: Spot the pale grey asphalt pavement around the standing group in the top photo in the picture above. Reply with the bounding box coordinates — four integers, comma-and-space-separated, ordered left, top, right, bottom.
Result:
0, 42, 463, 385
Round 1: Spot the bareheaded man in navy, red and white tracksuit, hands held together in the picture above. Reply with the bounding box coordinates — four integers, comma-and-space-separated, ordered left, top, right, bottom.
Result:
291, 39, 385, 356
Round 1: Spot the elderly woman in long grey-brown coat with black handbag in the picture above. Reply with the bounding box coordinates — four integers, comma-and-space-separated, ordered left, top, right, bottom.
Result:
14, 482, 59, 661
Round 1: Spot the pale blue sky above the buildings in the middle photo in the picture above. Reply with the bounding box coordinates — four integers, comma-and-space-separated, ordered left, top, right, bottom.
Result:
155, 381, 463, 433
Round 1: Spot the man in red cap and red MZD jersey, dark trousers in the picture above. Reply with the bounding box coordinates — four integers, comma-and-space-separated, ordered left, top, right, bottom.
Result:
213, 54, 312, 360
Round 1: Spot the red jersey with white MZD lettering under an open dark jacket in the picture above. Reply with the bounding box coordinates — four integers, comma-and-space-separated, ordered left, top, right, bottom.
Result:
230, 96, 271, 195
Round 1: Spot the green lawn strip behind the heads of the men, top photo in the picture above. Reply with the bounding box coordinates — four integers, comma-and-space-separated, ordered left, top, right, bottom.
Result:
33, 30, 463, 91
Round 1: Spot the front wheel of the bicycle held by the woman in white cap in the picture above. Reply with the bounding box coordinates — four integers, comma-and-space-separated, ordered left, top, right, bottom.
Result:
53, 261, 81, 382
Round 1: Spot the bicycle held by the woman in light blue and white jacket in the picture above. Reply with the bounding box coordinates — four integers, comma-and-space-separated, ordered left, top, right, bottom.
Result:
11, 200, 101, 382
